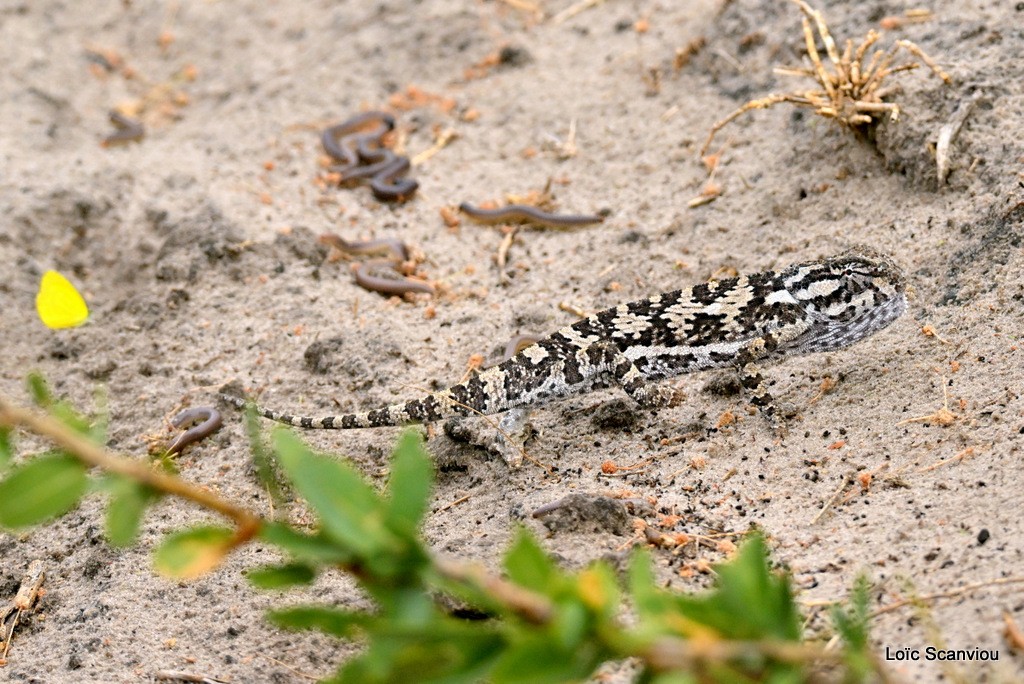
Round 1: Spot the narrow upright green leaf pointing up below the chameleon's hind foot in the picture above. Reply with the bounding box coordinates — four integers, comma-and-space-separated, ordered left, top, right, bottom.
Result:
388, 430, 434, 536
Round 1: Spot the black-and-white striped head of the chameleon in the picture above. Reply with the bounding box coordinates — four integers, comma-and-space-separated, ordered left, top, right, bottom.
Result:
784, 247, 906, 351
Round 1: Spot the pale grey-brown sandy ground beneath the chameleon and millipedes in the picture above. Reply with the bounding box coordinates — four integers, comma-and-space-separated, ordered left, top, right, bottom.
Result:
0, 0, 1024, 682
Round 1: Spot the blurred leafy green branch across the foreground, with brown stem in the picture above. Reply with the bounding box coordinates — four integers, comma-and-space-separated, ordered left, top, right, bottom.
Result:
0, 378, 876, 684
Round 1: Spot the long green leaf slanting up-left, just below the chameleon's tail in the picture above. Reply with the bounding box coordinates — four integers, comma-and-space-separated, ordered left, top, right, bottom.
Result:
273, 430, 402, 559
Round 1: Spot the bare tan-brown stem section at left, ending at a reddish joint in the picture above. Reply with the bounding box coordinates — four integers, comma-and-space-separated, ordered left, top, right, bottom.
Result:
0, 396, 263, 546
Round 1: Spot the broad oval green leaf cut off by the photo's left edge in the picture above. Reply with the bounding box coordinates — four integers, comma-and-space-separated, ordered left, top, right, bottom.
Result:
0, 454, 89, 529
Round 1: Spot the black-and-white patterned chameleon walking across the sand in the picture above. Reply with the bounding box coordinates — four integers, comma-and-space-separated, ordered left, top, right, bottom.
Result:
221, 248, 907, 430
